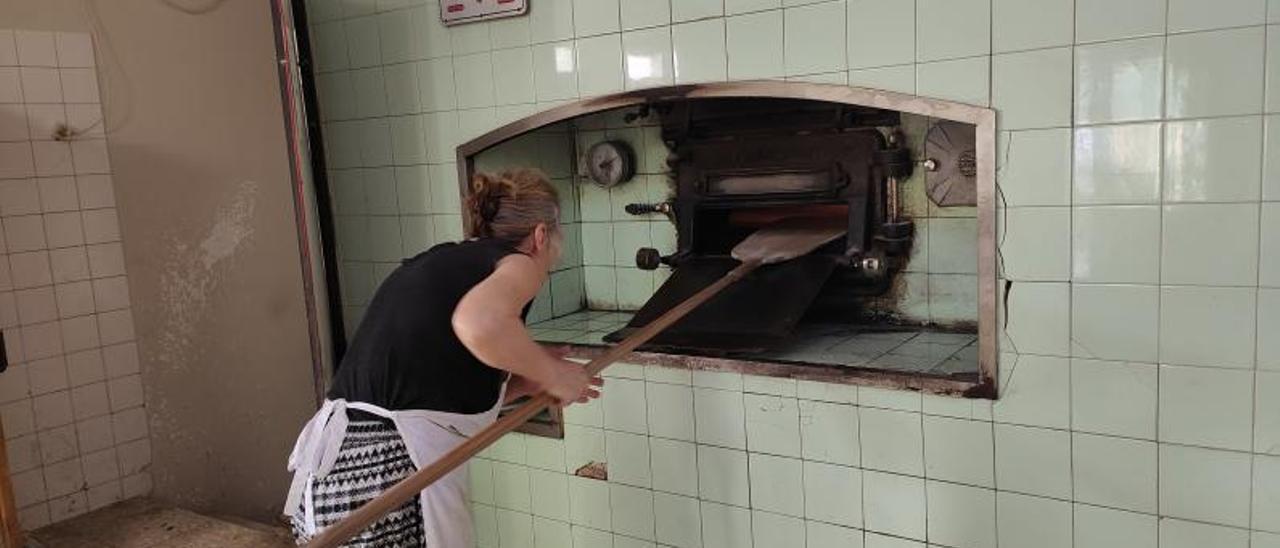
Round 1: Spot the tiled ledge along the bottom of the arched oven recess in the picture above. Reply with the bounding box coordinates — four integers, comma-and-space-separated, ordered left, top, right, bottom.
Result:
530, 310, 978, 375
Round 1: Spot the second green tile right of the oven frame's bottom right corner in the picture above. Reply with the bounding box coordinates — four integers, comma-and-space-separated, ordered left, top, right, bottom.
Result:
1071, 360, 1169, 439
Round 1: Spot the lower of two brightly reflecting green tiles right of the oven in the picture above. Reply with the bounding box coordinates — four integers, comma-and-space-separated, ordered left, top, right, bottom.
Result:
1073, 124, 1161, 205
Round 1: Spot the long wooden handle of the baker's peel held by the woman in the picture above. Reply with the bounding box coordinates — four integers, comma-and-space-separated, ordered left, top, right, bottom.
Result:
307, 260, 760, 548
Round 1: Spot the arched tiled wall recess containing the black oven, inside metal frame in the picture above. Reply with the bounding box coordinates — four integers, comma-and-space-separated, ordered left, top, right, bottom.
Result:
460, 83, 995, 432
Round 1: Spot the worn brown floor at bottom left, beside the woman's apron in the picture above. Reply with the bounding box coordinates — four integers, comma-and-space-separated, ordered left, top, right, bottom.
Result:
27, 498, 294, 548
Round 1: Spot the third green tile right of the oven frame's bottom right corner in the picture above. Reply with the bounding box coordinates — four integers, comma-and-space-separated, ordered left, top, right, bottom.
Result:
1160, 365, 1253, 451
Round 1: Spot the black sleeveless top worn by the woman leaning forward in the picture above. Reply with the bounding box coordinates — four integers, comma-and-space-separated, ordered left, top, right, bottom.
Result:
329, 239, 529, 414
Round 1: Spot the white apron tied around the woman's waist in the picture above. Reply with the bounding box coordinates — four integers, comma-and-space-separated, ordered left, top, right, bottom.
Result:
284, 383, 507, 548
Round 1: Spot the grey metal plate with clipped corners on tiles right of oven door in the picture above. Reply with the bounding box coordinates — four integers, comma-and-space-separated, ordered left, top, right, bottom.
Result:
924, 120, 978, 207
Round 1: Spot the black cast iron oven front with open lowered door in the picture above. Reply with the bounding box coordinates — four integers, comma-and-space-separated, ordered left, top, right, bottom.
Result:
605, 99, 913, 355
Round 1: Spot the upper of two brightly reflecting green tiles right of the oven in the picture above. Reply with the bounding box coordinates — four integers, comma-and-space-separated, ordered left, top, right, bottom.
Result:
1075, 37, 1165, 124
